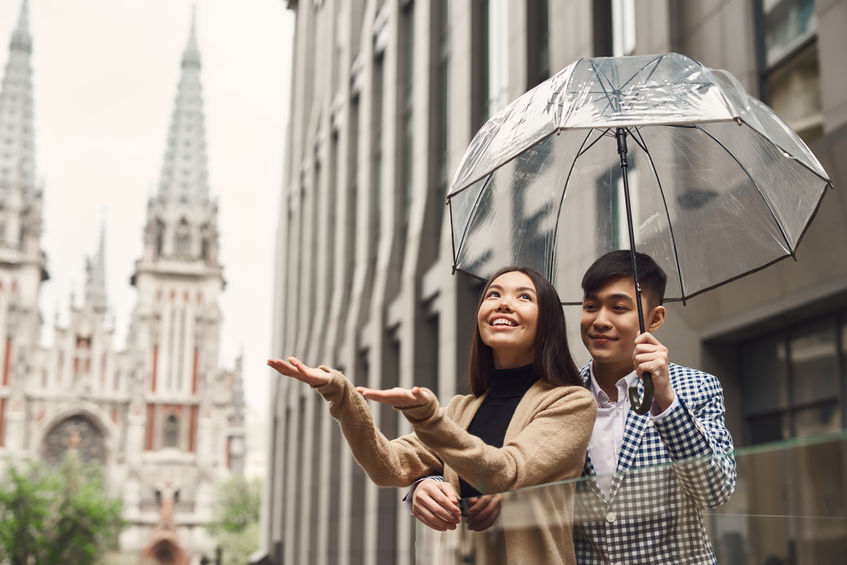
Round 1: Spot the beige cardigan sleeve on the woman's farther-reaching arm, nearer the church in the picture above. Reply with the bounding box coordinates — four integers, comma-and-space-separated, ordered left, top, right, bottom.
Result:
315, 371, 443, 487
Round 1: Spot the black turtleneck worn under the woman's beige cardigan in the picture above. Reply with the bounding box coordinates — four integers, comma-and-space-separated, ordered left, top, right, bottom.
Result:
459, 365, 538, 498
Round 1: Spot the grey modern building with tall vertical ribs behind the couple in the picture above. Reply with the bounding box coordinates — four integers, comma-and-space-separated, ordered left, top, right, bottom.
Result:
263, 0, 847, 565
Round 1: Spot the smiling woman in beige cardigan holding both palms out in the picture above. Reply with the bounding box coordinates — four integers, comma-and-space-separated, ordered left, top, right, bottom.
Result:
268, 267, 597, 563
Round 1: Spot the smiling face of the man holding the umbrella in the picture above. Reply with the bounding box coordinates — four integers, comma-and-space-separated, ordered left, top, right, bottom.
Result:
579, 278, 649, 378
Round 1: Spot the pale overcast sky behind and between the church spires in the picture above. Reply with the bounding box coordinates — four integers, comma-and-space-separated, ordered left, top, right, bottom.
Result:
0, 0, 294, 413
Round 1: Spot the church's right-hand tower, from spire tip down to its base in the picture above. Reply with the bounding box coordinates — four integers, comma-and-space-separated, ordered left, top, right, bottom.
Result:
122, 9, 237, 556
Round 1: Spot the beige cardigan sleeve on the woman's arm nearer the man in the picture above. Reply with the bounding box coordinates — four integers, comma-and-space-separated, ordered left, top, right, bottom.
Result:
402, 386, 597, 494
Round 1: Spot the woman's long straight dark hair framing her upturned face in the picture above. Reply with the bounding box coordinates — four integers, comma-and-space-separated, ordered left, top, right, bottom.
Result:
468, 266, 583, 396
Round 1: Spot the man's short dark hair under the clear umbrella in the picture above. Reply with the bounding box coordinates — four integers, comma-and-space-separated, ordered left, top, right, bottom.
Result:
582, 249, 668, 306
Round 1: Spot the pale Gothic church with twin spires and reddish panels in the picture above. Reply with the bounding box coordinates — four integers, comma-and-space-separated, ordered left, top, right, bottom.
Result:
0, 0, 245, 565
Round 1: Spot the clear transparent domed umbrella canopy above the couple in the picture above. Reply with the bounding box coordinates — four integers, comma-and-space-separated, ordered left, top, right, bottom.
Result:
447, 53, 830, 304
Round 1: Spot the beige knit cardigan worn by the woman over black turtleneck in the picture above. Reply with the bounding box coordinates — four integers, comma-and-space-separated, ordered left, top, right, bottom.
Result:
316, 371, 597, 565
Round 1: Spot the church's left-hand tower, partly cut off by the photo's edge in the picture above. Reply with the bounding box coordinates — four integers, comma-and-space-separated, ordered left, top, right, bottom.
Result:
0, 0, 47, 451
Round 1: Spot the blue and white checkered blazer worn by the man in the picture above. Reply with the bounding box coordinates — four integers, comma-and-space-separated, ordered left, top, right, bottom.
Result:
573, 363, 735, 565
